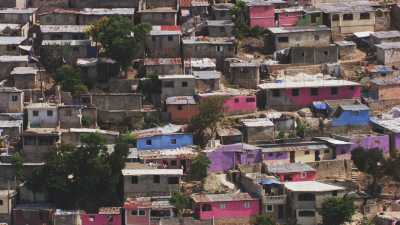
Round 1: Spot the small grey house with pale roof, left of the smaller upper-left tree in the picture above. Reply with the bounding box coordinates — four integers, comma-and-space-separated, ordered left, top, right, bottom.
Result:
10, 67, 39, 89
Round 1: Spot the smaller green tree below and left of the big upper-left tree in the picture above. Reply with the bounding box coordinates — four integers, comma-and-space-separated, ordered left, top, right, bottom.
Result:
54, 65, 88, 96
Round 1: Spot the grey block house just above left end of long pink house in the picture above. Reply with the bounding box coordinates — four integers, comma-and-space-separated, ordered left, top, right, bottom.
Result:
225, 59, 260, 89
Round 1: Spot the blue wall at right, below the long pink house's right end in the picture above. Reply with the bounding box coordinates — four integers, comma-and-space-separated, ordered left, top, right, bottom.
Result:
332, 110, 369, 127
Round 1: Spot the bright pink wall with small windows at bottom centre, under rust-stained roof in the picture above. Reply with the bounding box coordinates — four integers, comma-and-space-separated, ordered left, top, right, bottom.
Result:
195, 199, 260, 220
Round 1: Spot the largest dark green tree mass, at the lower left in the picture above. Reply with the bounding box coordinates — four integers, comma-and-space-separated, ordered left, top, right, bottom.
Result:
27, 134, 128, 212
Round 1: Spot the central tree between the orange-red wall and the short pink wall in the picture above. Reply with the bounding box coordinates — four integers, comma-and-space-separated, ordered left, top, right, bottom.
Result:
190, 96, 225, 146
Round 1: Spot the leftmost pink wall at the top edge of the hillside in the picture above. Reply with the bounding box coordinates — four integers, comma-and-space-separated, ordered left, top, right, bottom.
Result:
249, 5, 275, 28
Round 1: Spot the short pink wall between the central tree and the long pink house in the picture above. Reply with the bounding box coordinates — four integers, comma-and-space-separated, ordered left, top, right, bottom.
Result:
224, 95, 257, 114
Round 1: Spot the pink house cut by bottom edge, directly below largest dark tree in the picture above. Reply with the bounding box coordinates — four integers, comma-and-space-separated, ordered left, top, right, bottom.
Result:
80, 207, 122, 225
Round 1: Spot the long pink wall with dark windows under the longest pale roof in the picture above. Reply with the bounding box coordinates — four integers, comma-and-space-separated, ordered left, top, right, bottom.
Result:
285, 86, 361, 107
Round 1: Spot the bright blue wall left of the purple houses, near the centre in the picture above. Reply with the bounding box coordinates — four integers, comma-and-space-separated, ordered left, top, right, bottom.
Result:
137, 134, 193, 150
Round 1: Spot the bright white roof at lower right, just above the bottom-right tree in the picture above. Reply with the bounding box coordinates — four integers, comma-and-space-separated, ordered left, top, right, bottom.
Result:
284, 181, 345, 192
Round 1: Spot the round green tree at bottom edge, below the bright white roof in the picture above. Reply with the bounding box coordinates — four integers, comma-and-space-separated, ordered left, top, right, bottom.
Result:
320, 197, 356, 225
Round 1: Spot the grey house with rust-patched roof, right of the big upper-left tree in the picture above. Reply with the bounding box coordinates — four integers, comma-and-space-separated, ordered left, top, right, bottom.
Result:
143, 58, 183, 76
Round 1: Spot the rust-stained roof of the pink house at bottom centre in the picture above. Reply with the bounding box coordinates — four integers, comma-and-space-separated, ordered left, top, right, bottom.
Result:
192, 193, 255, 203
